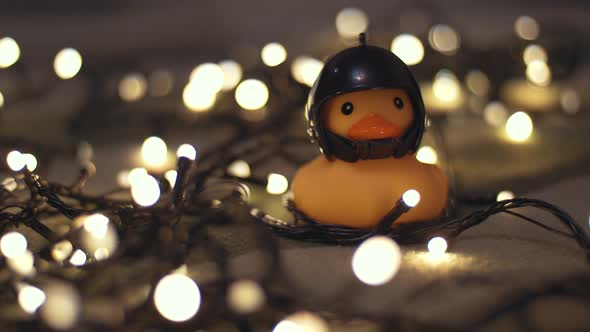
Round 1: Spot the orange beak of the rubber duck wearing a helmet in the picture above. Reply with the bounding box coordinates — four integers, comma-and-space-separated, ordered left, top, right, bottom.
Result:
348, 113, 402, 140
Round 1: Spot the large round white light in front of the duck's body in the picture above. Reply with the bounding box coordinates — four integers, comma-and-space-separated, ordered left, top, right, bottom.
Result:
352, 235, 402, 286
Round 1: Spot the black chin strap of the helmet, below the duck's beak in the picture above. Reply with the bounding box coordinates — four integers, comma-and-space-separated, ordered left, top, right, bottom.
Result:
325, 130, 408, 163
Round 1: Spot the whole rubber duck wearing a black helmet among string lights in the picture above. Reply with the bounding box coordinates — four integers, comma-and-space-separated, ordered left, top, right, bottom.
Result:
292, 34, 448, 228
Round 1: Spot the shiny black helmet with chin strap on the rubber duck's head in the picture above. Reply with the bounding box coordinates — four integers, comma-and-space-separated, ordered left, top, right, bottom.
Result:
306, 34, 425, 162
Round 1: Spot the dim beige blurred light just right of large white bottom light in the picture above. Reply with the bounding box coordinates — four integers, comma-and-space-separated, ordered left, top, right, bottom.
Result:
227, 280, 266, 314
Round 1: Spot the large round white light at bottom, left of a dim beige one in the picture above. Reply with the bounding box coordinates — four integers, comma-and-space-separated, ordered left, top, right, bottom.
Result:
154, 274, 201, 322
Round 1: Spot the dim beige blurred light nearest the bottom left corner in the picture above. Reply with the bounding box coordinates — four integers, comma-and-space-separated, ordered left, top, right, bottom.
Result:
40, 283, 81, 330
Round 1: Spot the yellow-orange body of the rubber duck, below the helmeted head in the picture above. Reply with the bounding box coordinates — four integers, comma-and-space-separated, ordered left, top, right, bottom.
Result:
292, 155, 448, 228
